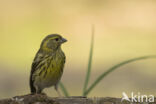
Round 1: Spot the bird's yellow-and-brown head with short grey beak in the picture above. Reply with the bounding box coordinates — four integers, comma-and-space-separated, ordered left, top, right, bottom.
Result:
41, 34, 67, 51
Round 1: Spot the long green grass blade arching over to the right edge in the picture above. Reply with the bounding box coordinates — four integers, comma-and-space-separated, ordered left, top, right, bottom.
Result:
84, 55, 156, 96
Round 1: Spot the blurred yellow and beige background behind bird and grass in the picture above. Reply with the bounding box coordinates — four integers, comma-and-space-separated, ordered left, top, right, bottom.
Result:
0, 0, 156, 98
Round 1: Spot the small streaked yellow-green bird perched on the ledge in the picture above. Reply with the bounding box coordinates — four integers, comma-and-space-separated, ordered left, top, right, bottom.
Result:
29, 34, 67, 96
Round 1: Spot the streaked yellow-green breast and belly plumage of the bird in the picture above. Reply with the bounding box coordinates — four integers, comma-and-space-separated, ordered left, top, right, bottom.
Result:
34, 49, 65, 87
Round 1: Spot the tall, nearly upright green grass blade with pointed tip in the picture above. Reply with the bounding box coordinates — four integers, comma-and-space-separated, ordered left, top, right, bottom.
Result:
83, 25, 94, 96
